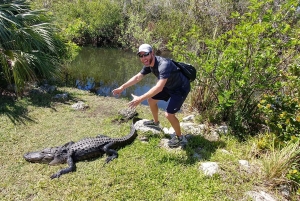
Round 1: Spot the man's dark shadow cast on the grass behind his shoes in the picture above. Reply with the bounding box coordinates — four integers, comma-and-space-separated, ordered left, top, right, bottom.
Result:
161, 135, 226, 165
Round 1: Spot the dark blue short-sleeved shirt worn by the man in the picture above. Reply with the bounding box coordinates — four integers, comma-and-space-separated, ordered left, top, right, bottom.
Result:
140, 56, 190, 91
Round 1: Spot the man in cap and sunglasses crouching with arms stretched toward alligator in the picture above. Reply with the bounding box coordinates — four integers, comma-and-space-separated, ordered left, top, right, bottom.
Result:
112, 44, 191, 147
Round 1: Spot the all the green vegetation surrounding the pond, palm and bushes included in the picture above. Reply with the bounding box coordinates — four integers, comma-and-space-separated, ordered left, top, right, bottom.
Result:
0, 0, 300, 199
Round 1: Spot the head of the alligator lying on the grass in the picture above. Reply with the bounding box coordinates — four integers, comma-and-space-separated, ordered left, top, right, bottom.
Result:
23, 142, 74, 165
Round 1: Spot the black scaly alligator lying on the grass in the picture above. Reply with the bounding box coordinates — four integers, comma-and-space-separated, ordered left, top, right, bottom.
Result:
23, 118, 140, 179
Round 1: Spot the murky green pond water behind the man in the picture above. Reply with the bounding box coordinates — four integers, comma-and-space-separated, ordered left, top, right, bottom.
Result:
69, 47, 171, 109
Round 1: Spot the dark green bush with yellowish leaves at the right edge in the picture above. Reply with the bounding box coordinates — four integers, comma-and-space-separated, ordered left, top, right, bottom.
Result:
258, 64, 300, 141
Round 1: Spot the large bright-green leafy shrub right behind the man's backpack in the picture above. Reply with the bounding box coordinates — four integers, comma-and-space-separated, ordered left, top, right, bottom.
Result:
169, 0, 299, 134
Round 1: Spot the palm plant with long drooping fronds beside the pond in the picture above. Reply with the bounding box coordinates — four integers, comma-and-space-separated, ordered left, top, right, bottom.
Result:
0, 0, 66, 94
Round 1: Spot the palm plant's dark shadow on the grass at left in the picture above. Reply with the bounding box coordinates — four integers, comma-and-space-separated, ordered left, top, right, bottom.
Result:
0, 88, 81, 124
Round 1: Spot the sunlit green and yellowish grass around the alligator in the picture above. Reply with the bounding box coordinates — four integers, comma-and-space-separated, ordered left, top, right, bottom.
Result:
0, 88, 298, 201
